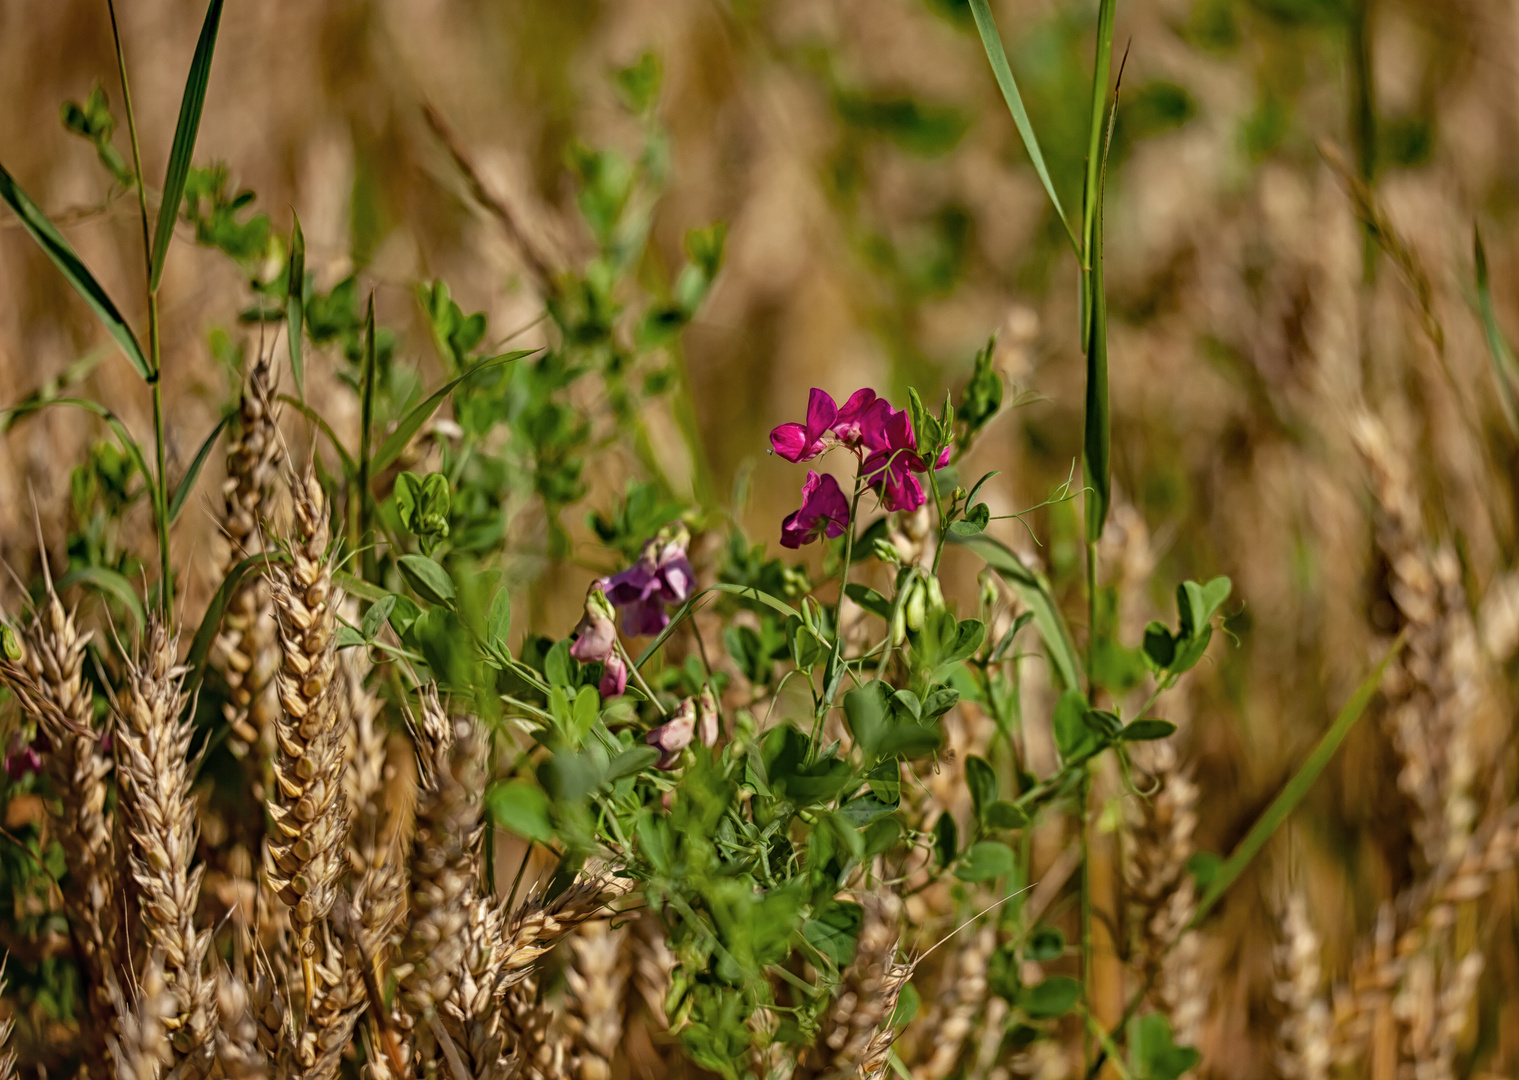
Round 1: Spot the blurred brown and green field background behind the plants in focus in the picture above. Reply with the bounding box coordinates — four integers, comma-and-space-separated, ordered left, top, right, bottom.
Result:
0, 0, 1519, 1077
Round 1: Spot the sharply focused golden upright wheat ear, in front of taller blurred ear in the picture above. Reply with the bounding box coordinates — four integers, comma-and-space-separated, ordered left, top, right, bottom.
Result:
264, 469, 348, 1007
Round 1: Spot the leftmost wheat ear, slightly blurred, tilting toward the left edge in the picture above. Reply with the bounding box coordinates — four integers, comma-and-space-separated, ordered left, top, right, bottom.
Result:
0, 577, 122, 1057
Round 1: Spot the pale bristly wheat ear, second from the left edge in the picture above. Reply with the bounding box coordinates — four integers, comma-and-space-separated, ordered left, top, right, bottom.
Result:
115, 615, 216, 1077
